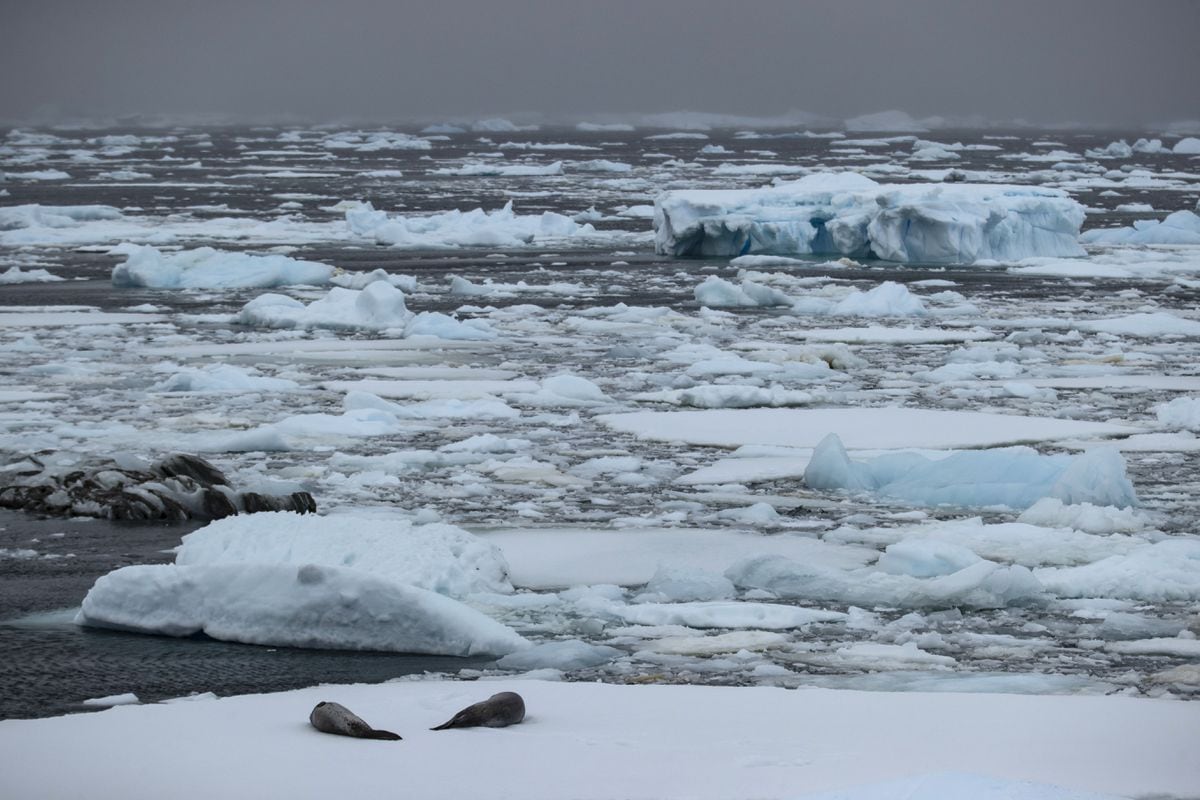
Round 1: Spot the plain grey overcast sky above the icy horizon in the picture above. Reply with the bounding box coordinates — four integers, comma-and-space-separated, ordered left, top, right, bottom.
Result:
0, 0, 1200, 124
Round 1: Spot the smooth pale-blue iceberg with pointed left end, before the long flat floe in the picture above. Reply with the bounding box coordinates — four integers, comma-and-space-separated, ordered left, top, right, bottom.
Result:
804, 433, 1138, 509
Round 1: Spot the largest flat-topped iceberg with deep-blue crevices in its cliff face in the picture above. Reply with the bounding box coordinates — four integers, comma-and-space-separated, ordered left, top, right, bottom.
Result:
654, 173, 1085, 264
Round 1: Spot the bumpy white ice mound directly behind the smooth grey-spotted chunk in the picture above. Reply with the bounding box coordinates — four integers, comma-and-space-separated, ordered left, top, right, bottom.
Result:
175, 512, 512, 597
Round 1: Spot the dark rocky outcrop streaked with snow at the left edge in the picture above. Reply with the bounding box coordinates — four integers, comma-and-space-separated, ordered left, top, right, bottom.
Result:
0, 453, 317, 521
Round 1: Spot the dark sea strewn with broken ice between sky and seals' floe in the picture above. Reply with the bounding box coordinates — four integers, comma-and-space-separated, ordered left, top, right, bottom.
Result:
0, 123, 1200, 716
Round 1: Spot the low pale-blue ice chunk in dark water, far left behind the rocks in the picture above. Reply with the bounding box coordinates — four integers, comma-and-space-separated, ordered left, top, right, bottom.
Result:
113, 245, 334, 289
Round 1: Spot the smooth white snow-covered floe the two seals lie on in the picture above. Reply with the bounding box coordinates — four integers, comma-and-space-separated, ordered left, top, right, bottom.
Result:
0, 680, 1200, 800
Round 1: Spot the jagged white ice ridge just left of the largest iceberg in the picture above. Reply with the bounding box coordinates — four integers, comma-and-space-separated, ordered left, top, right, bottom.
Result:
346, 200, 596, 248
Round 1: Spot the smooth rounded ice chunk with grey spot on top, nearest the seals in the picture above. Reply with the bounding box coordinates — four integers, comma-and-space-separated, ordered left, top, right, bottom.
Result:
77, 564, 526, 656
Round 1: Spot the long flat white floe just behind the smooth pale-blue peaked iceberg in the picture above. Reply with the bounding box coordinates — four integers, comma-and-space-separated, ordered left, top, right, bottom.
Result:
598, 408, 1141, 450
